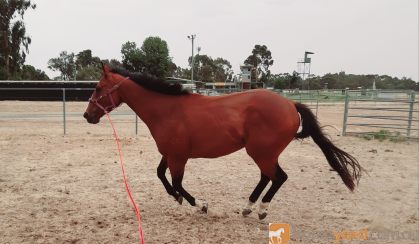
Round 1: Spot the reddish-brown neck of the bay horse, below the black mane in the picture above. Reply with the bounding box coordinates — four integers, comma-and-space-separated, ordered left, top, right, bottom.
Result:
119, 80, 176, 127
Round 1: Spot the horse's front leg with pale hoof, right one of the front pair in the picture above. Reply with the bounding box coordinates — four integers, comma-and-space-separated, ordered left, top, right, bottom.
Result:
169, 159, 208, 213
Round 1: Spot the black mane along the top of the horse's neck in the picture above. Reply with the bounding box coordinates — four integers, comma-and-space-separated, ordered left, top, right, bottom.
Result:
111, 67, 190, 96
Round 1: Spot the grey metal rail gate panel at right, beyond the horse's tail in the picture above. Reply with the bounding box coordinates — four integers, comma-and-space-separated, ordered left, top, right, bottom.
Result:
342, 90, 419, 138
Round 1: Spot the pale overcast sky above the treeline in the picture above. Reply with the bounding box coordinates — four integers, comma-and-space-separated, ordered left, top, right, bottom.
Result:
24, 0, 419, 81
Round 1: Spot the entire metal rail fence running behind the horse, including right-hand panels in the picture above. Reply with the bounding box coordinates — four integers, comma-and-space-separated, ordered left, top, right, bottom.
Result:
0, 88, 419, 138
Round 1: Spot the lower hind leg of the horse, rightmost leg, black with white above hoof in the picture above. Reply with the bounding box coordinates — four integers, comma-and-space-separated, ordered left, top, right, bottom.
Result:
258, 164, 288, 220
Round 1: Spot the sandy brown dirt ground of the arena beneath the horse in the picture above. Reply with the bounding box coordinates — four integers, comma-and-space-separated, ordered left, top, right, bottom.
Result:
0, 101, 419, 243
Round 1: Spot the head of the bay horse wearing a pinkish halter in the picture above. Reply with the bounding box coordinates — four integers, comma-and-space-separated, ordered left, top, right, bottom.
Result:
83, 64, 123, 124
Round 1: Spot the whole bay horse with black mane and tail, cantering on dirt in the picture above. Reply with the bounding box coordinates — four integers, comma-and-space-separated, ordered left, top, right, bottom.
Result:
83, 65, 362, 219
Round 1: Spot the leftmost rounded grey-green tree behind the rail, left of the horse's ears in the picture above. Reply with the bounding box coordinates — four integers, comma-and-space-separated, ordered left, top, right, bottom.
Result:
48, 51, 76, 80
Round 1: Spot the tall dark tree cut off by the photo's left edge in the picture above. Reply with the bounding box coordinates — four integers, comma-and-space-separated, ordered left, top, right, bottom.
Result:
0, 0, 36, 79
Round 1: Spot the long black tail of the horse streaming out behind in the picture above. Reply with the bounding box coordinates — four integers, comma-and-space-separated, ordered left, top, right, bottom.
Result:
295, 103, 362, 191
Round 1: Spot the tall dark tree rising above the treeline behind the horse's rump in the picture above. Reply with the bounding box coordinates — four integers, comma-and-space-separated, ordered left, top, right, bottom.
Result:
244, 44, 274, 83
